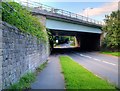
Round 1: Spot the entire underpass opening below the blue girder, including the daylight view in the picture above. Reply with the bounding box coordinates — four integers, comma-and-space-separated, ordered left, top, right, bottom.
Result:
49, 30, 100, 52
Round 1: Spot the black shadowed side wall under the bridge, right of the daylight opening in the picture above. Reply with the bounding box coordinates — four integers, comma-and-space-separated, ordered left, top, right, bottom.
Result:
80, 33, 100, 51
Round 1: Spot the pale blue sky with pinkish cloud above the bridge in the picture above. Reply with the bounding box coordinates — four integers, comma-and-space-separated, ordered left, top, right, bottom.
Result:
14, 0, 119, 21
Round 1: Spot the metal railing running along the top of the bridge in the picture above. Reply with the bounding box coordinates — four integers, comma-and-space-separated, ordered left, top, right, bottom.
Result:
3, 0, 104, 25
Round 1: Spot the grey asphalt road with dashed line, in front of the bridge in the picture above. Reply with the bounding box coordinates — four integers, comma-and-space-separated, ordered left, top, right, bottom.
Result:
67, 52, 120, 86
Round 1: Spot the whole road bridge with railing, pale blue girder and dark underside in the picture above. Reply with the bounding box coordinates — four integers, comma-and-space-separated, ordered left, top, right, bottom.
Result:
23, 3, 103, 50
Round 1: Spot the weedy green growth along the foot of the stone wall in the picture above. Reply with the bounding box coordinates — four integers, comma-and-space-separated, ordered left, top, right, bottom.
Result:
9, 61, 47, 91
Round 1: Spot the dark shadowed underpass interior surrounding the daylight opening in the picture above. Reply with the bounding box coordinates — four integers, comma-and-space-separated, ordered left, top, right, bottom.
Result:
49, 29, 100, 51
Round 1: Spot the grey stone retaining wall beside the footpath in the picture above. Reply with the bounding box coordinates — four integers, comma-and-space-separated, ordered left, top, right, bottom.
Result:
0, 22, 49, 89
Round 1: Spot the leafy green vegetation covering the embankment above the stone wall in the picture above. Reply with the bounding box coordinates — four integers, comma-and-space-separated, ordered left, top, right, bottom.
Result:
2, 2, 47, 41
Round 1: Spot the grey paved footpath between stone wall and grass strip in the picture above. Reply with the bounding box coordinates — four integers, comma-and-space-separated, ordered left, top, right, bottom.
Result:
31, 55, 65, 89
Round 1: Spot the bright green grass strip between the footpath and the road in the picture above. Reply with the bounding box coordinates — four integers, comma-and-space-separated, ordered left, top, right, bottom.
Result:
60, 56, 115, 89
